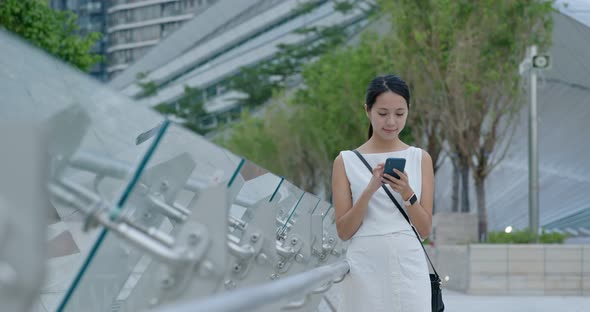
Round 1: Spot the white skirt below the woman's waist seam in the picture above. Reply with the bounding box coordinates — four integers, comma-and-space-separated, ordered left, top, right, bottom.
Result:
338, 231, 431, 312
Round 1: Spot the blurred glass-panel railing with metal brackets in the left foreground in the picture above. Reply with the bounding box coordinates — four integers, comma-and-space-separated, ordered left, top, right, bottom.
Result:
0, 30, 346, 312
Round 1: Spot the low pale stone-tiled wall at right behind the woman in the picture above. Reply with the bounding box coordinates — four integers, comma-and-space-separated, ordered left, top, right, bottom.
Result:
429, 244, 590, 296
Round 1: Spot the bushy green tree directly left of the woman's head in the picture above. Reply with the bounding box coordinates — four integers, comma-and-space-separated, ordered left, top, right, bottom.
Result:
219, 34, 412, 197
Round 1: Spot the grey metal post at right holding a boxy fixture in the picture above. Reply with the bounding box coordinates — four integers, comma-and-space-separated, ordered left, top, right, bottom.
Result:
529, 45, 539, 242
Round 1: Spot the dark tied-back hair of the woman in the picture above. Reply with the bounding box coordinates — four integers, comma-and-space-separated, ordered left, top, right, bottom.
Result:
365, 75, 410, 139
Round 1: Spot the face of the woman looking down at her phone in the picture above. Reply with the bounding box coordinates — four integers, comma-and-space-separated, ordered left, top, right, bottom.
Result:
365, 92, 408, 140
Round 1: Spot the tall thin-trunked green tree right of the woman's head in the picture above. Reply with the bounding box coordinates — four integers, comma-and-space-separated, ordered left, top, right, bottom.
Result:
379, 0, 553, 240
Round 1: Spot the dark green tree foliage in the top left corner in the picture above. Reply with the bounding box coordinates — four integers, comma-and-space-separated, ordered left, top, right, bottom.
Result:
0, 0, 102, 71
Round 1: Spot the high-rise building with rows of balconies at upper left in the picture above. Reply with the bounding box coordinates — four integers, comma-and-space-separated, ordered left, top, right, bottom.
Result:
51, 0, 216, 81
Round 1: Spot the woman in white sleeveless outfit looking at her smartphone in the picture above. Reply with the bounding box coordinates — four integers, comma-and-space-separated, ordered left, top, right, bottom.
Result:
332, 75, 434, 312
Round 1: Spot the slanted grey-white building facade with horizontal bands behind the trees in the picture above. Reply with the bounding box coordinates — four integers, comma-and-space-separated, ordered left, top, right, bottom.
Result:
110, 0, 368, 129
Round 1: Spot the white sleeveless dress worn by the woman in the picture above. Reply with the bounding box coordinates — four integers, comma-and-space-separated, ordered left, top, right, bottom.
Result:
338, 147, 431, 312
